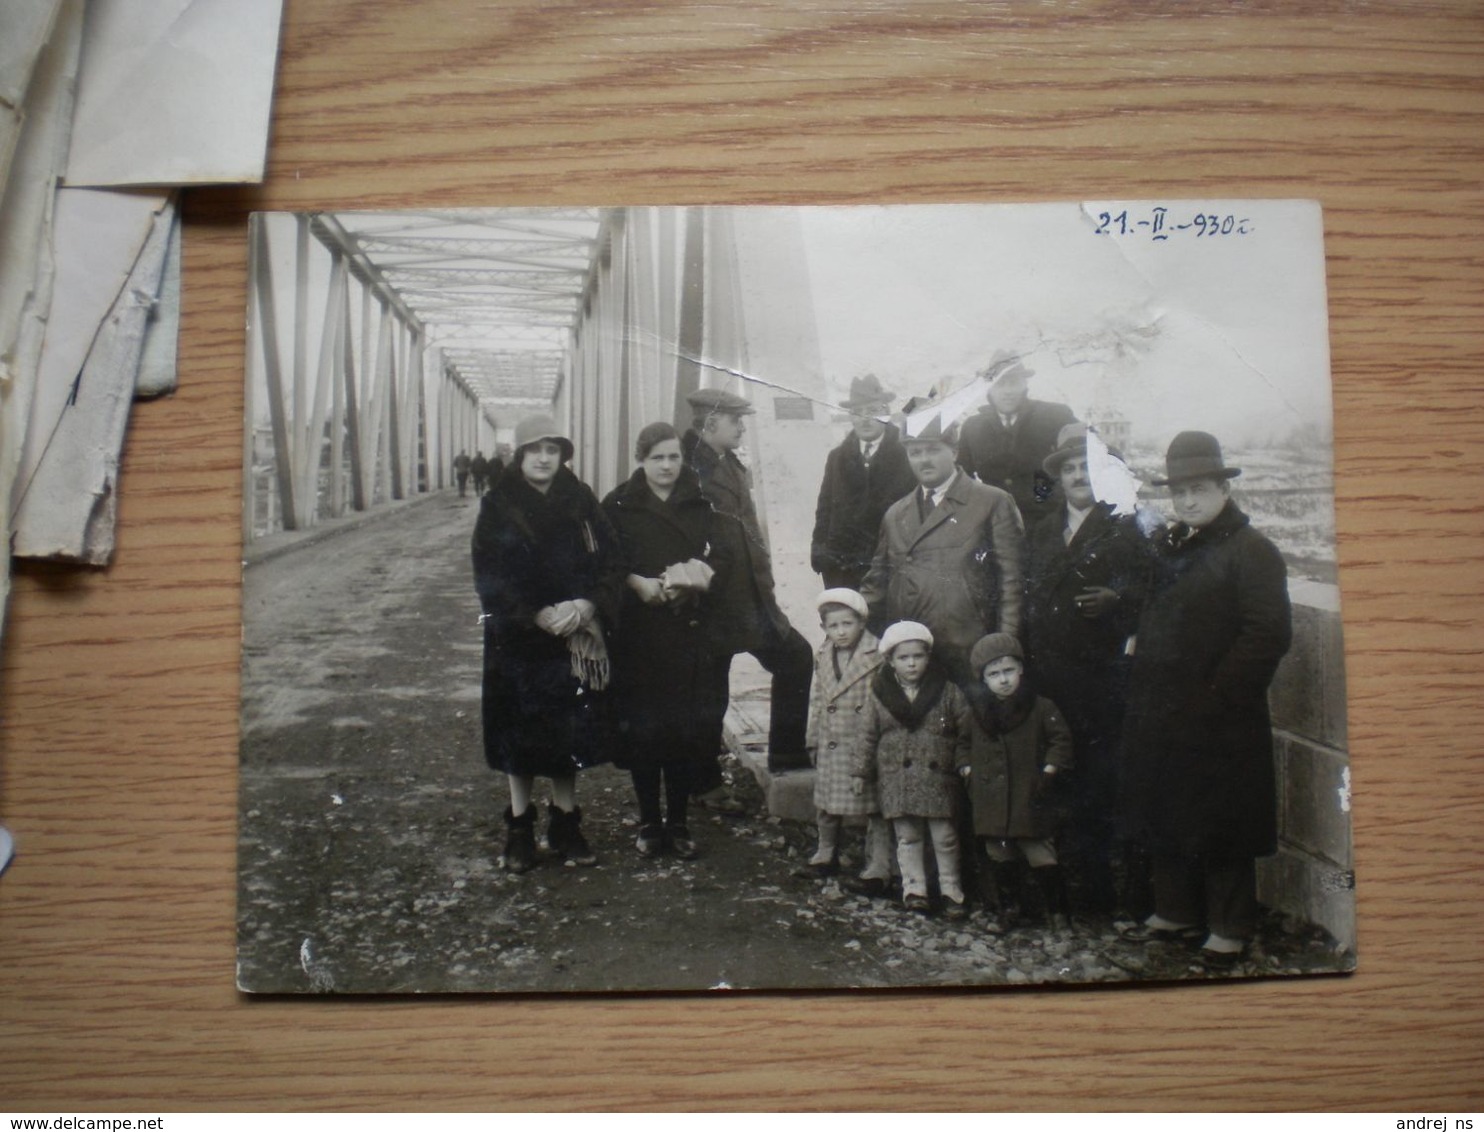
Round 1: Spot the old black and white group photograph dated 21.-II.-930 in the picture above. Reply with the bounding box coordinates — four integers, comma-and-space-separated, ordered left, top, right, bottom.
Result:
237, 200, 1356, 994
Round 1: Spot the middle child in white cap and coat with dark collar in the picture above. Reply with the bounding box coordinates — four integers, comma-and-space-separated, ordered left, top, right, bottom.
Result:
850, 622, 974, 920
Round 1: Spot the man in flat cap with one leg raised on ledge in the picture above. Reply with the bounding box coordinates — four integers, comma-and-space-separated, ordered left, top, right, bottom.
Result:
681, 389, 815, 783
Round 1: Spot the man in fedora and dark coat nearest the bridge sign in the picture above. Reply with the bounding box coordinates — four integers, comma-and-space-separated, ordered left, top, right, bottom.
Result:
809, 374, 917, 590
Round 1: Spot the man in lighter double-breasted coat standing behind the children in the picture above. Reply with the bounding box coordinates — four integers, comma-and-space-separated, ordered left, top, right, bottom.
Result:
861, 414, 1025, 687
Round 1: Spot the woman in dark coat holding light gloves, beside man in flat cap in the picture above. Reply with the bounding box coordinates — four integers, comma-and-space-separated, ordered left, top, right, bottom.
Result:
603, 421, 730, 859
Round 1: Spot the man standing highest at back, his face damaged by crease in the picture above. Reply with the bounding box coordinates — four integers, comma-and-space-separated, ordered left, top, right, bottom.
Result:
959, 350, 1074, 527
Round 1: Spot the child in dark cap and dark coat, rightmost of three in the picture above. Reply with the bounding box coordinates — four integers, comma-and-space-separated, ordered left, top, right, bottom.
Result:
959, 634, 1071, 932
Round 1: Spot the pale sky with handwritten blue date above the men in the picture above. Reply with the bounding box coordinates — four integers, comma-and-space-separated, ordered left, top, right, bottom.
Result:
803, 200, 1331, 444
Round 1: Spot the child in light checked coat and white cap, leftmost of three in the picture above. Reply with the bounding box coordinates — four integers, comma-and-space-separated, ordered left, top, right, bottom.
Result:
804, 588, 892, 896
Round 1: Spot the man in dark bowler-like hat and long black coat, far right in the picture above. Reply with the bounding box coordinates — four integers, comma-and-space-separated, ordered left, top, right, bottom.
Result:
1123, 432, 1291, 967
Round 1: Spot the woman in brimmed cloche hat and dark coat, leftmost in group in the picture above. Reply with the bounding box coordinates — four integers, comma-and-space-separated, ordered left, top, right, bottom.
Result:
473, 417, 623, 872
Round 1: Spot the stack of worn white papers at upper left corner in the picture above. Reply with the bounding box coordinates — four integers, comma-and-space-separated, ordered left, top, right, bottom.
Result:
0, 0, 282, 637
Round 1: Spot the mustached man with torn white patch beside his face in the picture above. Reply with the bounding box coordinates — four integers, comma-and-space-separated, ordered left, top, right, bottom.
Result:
1025, 421, 1152, 917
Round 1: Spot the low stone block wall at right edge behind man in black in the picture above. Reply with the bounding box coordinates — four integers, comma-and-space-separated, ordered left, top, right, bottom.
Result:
1258, 582, 1355, 951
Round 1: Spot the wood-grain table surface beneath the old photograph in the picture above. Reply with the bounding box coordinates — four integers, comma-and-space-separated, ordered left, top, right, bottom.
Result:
0, 0, 1484, 1113
